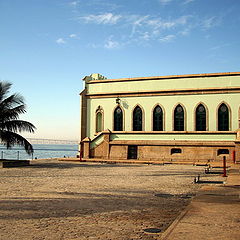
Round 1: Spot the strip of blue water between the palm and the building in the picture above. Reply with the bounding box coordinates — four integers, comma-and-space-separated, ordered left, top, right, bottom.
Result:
0, 144, 78, 160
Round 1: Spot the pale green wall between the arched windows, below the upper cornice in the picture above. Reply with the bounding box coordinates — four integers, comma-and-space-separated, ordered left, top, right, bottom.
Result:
87, 94, 240, 138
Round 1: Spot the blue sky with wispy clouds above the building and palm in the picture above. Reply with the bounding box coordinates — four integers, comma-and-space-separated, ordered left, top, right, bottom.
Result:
0, 0, 240, 139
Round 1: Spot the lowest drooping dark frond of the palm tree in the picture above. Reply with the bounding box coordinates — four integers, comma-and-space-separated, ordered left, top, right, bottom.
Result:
0, 130, 34, 155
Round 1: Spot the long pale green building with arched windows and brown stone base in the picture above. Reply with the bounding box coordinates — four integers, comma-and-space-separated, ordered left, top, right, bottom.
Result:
81, 72, 240, 162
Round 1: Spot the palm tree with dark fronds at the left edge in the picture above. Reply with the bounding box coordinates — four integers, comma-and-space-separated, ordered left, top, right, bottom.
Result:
0, 82, 36, 155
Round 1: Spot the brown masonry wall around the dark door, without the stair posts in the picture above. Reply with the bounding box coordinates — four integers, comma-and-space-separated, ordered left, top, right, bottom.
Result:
86, 137, 234, 162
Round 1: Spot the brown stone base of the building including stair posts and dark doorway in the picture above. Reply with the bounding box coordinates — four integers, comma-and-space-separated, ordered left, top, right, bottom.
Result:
82, 131, 240, 162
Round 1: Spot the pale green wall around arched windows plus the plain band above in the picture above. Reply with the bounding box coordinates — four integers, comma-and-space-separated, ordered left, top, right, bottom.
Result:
81, 76, 240, 139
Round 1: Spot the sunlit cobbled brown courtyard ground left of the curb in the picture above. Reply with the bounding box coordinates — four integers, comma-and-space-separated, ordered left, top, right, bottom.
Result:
0, 160, 216, 240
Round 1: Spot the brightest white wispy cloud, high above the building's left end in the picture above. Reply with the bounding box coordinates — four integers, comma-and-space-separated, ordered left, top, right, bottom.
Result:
80, 13, 122, 24
